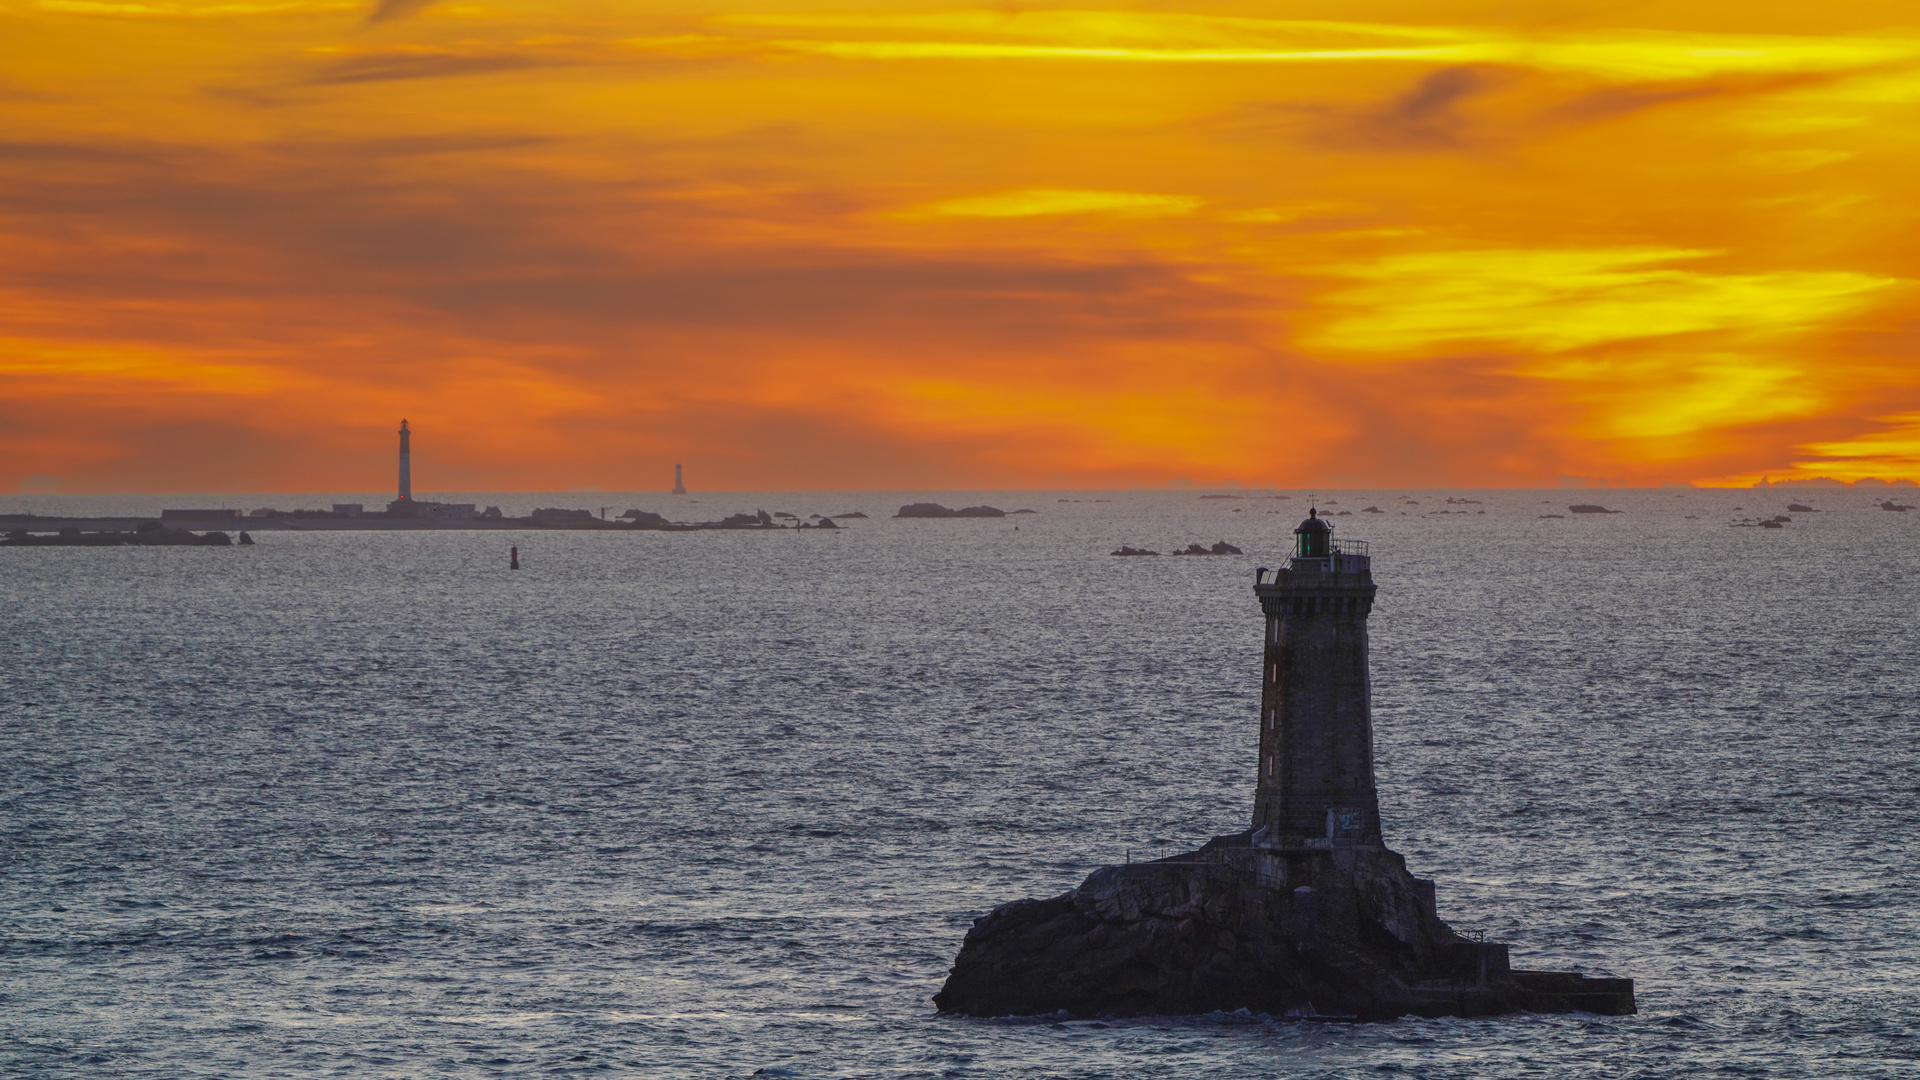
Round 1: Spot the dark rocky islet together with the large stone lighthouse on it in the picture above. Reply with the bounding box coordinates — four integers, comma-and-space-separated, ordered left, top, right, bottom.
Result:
933, 511, 1634, 1020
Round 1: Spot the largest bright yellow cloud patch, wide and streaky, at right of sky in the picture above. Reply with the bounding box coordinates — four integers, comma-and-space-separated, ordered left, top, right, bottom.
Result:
1308, 248, 1893, 354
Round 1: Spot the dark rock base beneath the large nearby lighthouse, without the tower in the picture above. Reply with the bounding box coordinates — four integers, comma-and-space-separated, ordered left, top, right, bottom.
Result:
933, 834, 1634, 1020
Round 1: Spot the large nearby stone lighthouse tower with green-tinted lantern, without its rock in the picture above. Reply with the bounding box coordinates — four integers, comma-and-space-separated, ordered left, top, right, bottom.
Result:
1254, 509, 1380, 847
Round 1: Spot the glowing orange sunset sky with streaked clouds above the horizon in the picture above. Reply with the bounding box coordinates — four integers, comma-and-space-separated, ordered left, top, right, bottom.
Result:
0, 0, 1920, 492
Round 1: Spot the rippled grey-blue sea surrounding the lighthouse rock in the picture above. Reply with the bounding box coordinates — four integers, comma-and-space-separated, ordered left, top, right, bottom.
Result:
0, 488, 1920, 1080
